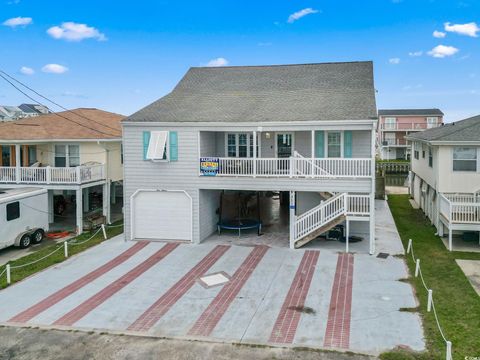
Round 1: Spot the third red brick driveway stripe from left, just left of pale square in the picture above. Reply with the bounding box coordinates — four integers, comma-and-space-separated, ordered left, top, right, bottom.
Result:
128, 245, 230, 331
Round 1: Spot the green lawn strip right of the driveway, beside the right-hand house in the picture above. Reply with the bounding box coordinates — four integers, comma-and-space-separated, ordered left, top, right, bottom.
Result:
382, 195, 480, 360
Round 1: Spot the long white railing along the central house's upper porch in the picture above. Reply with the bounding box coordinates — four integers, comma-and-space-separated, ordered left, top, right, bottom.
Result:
202, 157, 372, 178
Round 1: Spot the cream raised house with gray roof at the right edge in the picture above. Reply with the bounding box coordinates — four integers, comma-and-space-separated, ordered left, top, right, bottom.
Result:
407, 115, 480, 250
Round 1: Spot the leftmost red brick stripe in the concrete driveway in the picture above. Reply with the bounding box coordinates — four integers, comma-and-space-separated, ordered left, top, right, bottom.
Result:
8, 241, 148, 323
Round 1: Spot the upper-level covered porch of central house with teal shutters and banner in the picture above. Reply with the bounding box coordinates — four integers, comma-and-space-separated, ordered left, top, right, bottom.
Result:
199, 130, 374, 178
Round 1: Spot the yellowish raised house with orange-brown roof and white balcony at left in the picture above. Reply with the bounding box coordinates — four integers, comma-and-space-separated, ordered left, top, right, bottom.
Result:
0, 108, 124, 233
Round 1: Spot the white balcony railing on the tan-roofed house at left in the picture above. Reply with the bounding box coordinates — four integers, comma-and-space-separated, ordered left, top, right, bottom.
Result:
0, 164, 105, 184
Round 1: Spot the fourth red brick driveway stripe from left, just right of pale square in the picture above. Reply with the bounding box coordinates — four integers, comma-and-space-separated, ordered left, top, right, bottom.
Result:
189, 245, 268, 336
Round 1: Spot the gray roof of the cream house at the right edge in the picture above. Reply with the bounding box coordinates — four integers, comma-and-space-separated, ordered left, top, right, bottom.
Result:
408, 115, 480, 142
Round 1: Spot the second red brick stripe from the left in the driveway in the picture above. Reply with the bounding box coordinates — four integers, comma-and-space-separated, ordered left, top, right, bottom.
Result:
53, 243, 179, 326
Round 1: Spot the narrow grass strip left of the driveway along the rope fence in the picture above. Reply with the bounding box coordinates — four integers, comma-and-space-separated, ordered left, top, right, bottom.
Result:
0, 221, 123, 289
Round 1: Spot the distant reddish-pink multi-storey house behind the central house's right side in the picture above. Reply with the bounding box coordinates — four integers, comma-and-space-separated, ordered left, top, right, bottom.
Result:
377, 109, 443, 160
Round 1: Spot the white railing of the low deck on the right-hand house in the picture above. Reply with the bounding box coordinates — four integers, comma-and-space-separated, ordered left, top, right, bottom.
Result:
439, 194, 480, 224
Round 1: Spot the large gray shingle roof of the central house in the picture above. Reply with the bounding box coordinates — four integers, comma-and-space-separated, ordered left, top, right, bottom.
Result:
126, 61, 377, 122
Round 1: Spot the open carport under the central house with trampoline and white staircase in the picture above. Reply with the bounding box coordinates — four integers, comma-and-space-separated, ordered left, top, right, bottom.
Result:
200, 190, 373, 253
